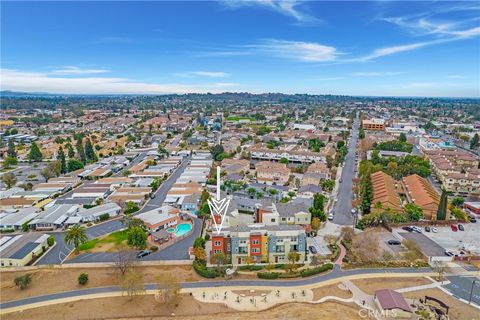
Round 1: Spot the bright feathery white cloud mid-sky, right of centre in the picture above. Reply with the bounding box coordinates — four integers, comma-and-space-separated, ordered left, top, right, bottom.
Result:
248, 40, 339, 62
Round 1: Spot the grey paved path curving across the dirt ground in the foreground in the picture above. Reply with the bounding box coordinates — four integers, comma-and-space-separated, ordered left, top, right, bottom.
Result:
0, 266, 452, 310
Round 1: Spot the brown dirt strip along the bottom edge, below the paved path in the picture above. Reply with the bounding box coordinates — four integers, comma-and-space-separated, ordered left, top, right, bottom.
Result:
2, 295, 365, 320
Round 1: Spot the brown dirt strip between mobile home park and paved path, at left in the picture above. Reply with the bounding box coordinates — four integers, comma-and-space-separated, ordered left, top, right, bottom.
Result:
0, 266, 203, 302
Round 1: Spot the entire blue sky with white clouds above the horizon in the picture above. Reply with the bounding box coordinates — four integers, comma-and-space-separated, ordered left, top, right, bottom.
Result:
0, 1, 480, 97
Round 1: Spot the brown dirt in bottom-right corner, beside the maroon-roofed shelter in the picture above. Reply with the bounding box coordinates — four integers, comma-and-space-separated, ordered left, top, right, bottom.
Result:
403, 289, 480, 320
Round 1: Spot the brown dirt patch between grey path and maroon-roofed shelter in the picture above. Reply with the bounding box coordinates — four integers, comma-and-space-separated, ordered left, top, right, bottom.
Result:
352, 277, 432, 294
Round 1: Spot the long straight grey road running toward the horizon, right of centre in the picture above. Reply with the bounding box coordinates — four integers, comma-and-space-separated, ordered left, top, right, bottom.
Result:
333, 117, 359, 225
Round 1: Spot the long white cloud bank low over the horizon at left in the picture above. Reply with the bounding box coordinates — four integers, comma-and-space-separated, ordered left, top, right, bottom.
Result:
0, 69, 241, 94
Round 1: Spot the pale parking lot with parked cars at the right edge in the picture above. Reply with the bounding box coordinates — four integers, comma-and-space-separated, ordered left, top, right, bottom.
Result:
424, 223, 480, 254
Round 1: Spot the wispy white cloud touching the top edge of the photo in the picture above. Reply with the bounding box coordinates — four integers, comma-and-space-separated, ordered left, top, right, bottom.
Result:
221, 0, 320, 24
